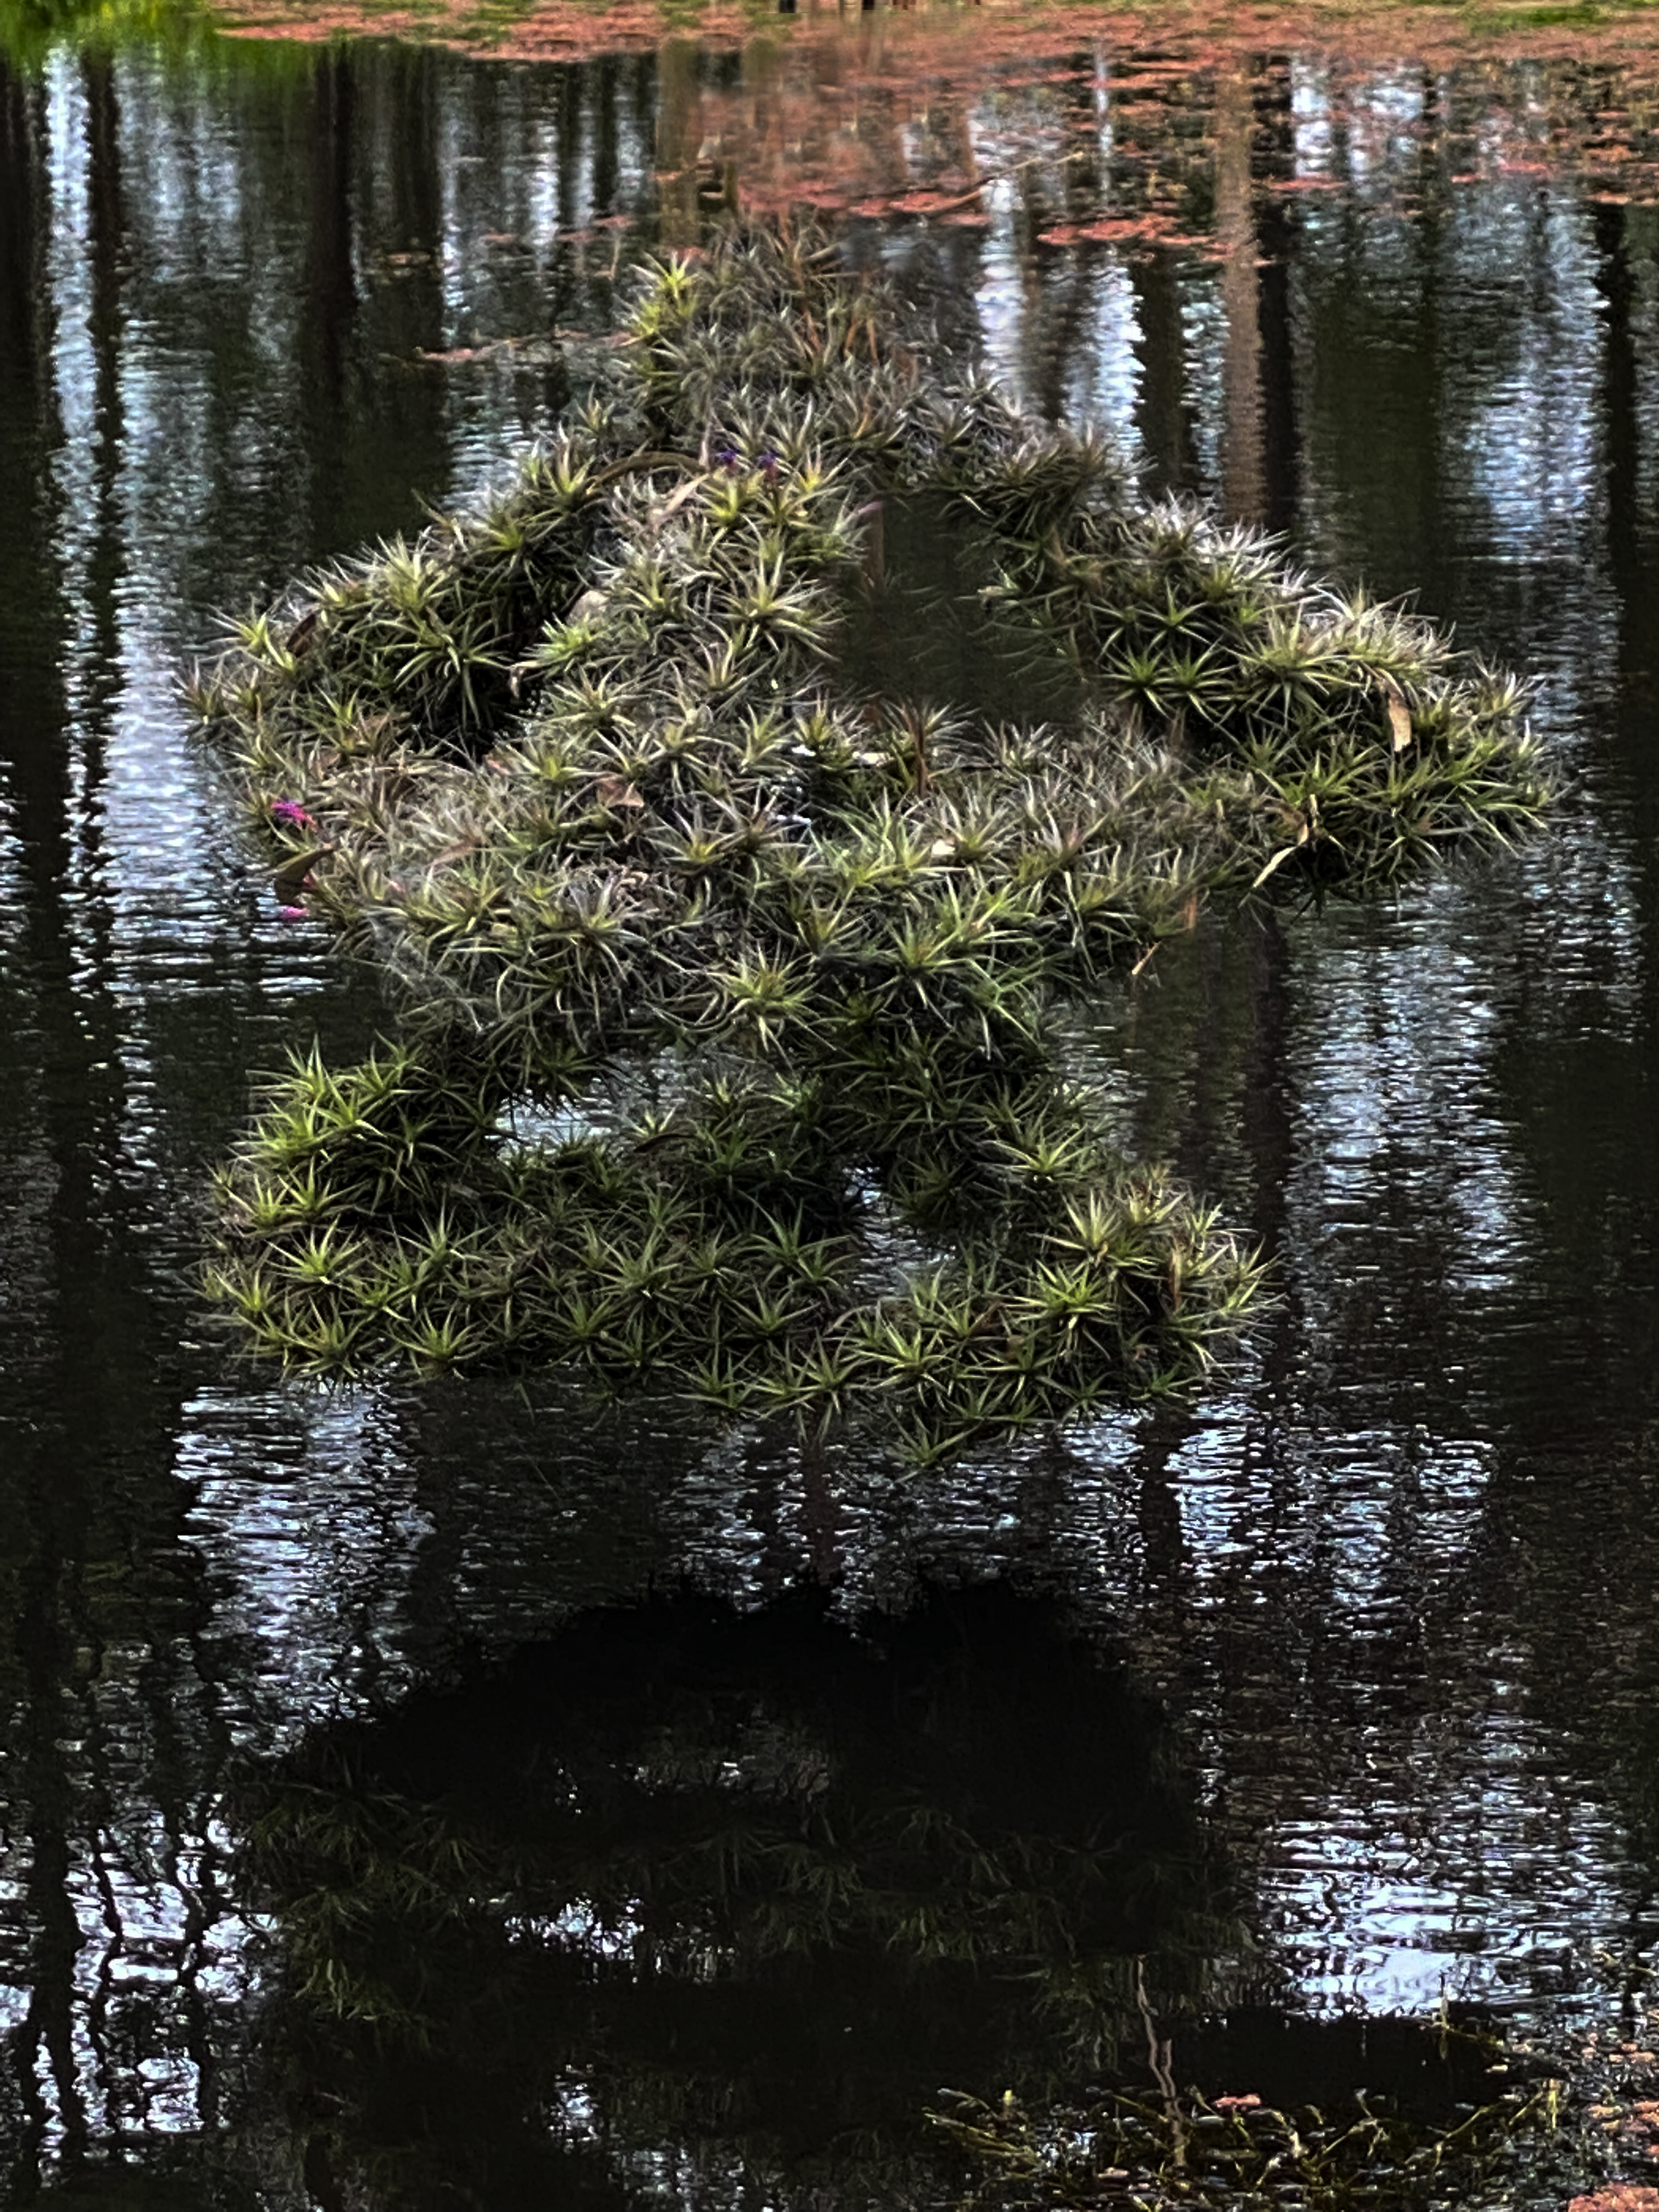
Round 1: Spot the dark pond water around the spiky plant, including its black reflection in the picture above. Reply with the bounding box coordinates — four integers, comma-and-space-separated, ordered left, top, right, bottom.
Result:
0, 9, 1659, 2208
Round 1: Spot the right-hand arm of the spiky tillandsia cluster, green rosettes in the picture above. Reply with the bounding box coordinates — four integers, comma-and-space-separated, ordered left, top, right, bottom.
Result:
1002, 506, 1548, 898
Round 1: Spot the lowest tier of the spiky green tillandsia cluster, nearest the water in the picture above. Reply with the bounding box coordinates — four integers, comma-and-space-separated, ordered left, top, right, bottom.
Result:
208, 1051, 1259, 1464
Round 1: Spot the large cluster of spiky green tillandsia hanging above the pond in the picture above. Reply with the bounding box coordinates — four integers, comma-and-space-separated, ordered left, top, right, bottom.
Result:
193, 232, 1548, 1462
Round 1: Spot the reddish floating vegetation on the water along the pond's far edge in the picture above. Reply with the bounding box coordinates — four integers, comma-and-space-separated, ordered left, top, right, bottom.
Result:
204, 0, 1659, 255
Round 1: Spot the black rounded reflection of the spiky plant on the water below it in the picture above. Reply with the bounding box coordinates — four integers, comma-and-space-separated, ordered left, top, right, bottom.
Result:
241, 1586, 1237, 2205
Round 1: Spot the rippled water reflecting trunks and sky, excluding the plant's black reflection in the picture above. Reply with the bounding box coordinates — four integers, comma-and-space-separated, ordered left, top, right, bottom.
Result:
0, 11, 1659, 2205
